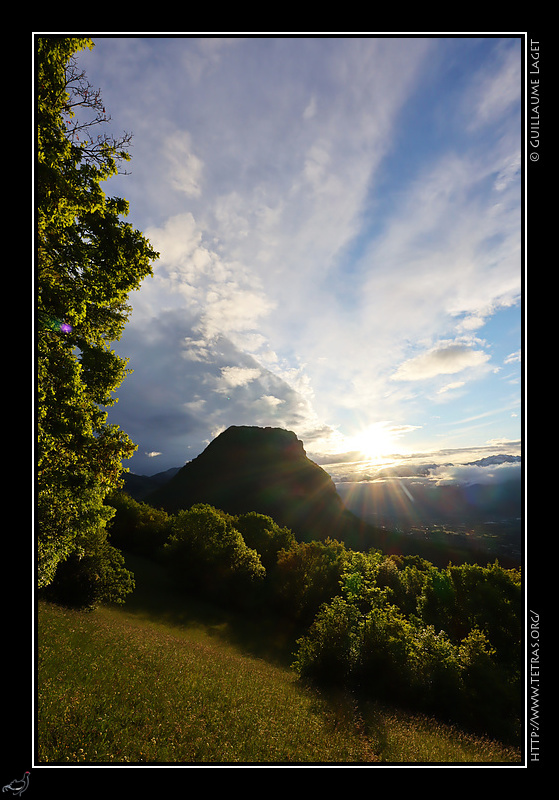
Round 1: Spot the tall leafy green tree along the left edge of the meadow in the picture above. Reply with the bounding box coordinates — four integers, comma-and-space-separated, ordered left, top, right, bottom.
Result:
35, 36, 158, 599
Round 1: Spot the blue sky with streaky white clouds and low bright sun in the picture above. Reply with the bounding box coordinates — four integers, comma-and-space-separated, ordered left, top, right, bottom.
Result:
71, 34, 523, 480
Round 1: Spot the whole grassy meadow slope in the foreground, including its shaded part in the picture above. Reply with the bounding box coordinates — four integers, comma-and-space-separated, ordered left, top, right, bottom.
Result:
37, 560, 520, 765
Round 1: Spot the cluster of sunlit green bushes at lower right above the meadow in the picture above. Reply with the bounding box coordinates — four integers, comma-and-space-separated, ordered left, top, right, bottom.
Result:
295, 551, 522, 738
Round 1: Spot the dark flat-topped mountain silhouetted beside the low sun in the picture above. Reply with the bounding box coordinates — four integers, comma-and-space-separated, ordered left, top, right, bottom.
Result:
144, 426, 367, 541
